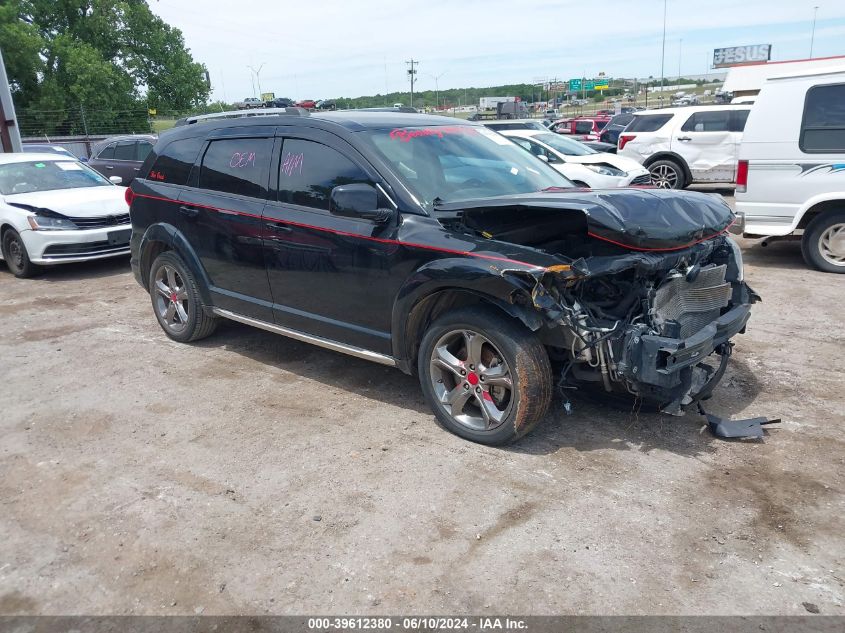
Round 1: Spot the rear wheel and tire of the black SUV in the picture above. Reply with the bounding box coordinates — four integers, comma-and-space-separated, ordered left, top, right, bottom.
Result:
149, 251, 218, 343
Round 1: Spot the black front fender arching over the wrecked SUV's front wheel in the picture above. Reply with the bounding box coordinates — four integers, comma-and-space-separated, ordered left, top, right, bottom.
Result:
391, 258, 545, 361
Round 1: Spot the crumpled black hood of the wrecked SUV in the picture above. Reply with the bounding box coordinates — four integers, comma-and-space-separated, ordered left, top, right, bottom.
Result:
435, 189, 735, 251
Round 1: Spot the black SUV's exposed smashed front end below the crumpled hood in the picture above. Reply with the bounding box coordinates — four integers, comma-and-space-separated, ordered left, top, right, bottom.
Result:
533, 236, 759, 415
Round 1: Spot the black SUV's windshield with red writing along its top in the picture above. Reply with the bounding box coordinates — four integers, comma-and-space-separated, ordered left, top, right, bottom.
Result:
362, 125, 572, 210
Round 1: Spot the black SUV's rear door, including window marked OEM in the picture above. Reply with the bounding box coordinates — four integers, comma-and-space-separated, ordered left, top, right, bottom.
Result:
176, 134, 273, 321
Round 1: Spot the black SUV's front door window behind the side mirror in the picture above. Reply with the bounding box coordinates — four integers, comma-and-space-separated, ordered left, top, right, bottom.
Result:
279, 139, 370, 211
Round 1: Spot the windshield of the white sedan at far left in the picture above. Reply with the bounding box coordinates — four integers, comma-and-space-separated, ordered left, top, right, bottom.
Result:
0, 160, 111, 196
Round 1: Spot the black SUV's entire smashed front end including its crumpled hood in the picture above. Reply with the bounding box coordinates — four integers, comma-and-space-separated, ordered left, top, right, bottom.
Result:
438, 190, 760, 415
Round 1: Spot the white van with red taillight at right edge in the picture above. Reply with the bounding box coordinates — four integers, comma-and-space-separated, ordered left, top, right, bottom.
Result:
734, 65, 845, 273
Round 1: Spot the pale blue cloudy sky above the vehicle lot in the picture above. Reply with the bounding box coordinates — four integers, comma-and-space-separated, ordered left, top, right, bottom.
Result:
149, 0, 845, 102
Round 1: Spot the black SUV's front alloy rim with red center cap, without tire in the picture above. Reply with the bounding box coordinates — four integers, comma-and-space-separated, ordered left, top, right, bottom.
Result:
429, 330, 514, 431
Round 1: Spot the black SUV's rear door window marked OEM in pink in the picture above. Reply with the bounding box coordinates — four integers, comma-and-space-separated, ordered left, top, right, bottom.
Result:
199, 138, 273, 198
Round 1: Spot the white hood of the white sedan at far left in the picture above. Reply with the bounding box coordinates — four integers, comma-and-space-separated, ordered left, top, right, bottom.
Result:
3, 185, 129, 218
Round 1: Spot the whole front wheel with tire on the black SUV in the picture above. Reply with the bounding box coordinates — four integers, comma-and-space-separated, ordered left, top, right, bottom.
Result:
417, 306, 552, 446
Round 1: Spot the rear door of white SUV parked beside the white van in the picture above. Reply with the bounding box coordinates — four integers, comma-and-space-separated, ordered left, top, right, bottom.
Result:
671, 110, 741, 182
